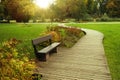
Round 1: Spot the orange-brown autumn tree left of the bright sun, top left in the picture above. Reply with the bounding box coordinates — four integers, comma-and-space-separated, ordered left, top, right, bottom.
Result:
6, 0, 34, 22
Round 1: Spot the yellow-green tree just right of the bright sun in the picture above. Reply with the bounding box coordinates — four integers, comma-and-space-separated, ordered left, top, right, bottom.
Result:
51, 0, 86, 20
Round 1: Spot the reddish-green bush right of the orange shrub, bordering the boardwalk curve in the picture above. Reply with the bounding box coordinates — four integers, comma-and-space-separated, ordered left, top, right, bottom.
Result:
62, 27, 84, 47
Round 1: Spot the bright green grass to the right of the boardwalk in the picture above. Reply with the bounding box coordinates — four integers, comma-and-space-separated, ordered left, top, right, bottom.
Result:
67, 22, 120, 80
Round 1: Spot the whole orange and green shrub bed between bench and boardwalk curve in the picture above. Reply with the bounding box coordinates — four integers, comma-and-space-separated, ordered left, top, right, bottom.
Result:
47, 26, 84, 47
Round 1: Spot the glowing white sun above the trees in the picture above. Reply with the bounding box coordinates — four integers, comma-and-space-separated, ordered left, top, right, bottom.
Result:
34, 0, 54, 8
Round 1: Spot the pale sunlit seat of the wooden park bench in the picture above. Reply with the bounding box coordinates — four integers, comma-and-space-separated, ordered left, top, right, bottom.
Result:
38, 42, 60, 53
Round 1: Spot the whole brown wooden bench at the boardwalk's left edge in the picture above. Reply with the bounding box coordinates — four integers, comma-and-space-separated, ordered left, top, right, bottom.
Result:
32, 35, 60, 61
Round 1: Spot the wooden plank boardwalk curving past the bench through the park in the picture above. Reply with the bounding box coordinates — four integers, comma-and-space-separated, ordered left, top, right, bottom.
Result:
37, 29, 111, 80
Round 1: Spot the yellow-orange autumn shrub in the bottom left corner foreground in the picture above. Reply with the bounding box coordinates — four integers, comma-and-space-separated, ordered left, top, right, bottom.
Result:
0, 39, 35, 80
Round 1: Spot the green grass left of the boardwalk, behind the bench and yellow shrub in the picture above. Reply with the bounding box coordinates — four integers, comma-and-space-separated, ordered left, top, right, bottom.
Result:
0, 24, 53, 58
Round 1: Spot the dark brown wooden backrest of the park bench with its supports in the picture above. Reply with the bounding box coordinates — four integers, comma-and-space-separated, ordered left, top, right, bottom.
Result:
32, 35, 52, 53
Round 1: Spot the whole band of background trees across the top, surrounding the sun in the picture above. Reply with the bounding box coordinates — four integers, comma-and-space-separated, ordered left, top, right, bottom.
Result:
0, 0, 120, 22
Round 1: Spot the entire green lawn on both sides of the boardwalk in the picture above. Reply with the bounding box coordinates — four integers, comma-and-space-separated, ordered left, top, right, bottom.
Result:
0, 22, 120, 80
